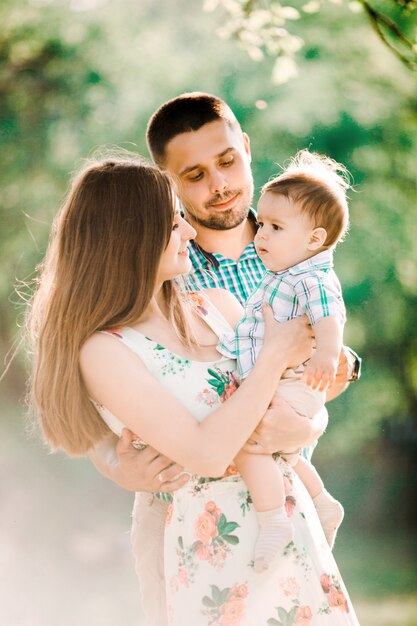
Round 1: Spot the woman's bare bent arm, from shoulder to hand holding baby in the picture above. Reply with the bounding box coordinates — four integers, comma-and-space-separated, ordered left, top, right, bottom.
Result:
80, 309, 309, 476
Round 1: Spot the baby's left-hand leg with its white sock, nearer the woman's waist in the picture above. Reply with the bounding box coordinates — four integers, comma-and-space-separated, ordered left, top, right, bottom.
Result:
235, 451, 294, 573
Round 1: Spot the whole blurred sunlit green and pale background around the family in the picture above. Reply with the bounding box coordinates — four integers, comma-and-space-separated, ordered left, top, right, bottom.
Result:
0, 0, 417, 626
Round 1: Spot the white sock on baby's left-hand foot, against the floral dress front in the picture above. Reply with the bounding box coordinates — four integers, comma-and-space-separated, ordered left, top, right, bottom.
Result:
254, 506, 294, 574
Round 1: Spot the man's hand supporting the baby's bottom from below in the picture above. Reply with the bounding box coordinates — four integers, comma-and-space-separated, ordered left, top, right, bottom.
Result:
240, 396, 328, 454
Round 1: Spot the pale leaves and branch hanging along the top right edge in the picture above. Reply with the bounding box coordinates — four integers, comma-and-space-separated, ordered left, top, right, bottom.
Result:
204, 0, 417, 85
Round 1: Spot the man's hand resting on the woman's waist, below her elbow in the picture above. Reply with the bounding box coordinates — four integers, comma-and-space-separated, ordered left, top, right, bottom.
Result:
89, 428, 189, 492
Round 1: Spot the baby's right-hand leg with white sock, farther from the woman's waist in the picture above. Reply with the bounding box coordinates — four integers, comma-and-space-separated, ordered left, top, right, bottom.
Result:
294, 456, 344, 548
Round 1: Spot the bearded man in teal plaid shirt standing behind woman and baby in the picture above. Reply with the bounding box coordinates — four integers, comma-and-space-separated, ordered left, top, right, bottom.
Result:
91, 93, 357, 626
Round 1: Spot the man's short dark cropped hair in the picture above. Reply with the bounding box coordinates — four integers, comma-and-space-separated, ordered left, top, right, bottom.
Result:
146, 91, 239, 165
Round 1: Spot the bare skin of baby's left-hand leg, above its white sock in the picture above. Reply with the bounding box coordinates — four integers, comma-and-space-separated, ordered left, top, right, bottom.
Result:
234, 450, 285, 511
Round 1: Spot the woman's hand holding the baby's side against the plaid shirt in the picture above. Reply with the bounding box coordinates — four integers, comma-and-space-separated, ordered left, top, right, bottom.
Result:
262, 304, 314, 367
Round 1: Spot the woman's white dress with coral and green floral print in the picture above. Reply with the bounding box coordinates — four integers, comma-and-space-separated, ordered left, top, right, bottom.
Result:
96, 292, 358, 626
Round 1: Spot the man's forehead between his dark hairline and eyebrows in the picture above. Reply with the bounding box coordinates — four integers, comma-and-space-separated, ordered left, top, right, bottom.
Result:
165, 120, 243, 176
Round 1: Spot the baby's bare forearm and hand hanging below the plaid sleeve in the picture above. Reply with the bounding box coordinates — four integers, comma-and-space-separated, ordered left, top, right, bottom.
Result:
303, 317, 343, 391
